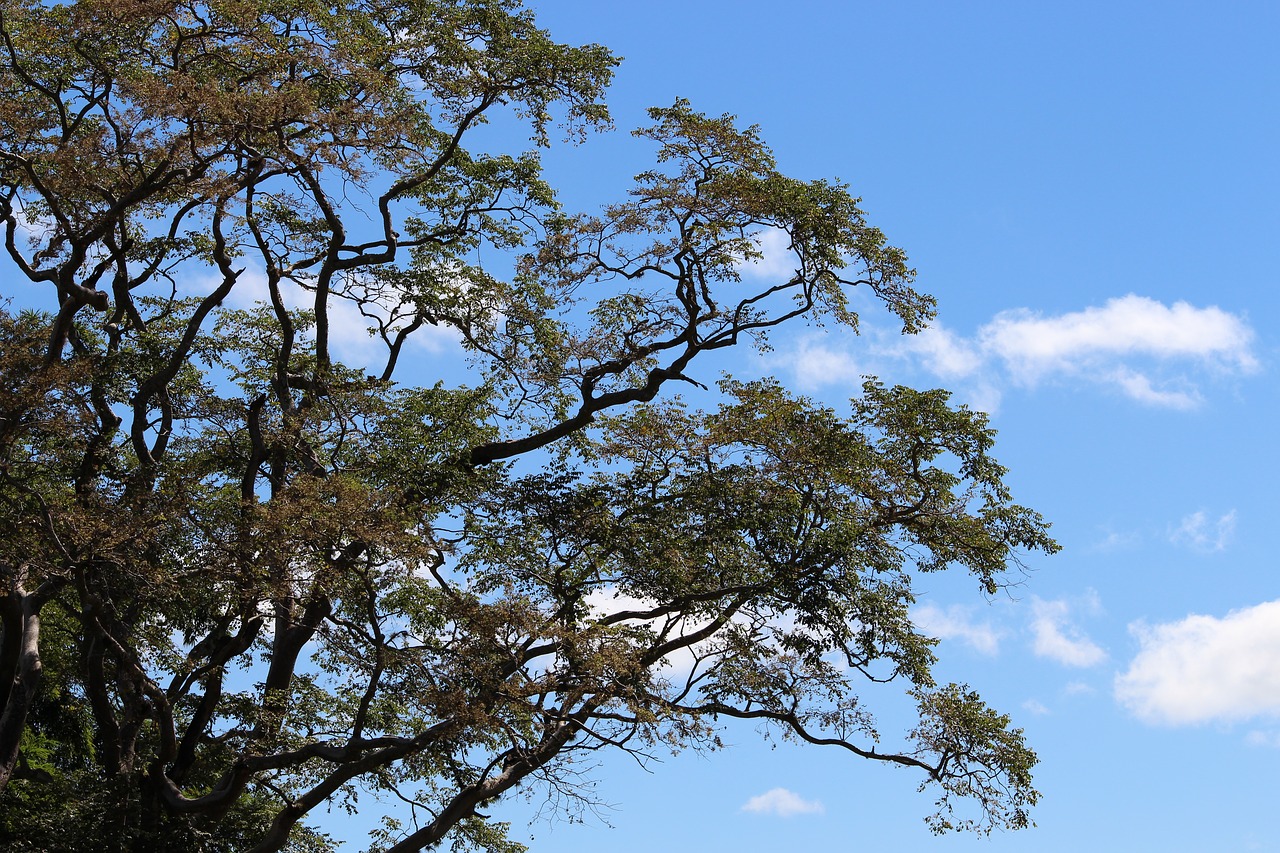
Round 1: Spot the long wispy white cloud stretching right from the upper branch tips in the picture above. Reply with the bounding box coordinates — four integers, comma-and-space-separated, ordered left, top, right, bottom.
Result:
780, 293, 1261, 411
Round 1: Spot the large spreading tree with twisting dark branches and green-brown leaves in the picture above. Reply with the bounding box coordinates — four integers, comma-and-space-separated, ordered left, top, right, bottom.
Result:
0, 0, 1056, 853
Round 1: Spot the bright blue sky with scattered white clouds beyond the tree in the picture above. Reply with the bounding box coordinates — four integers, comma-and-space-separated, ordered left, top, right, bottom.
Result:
5, 0, 1280, 853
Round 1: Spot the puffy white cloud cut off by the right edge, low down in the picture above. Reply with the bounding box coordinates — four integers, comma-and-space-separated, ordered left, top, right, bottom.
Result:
1115, 601, 1280, 725
